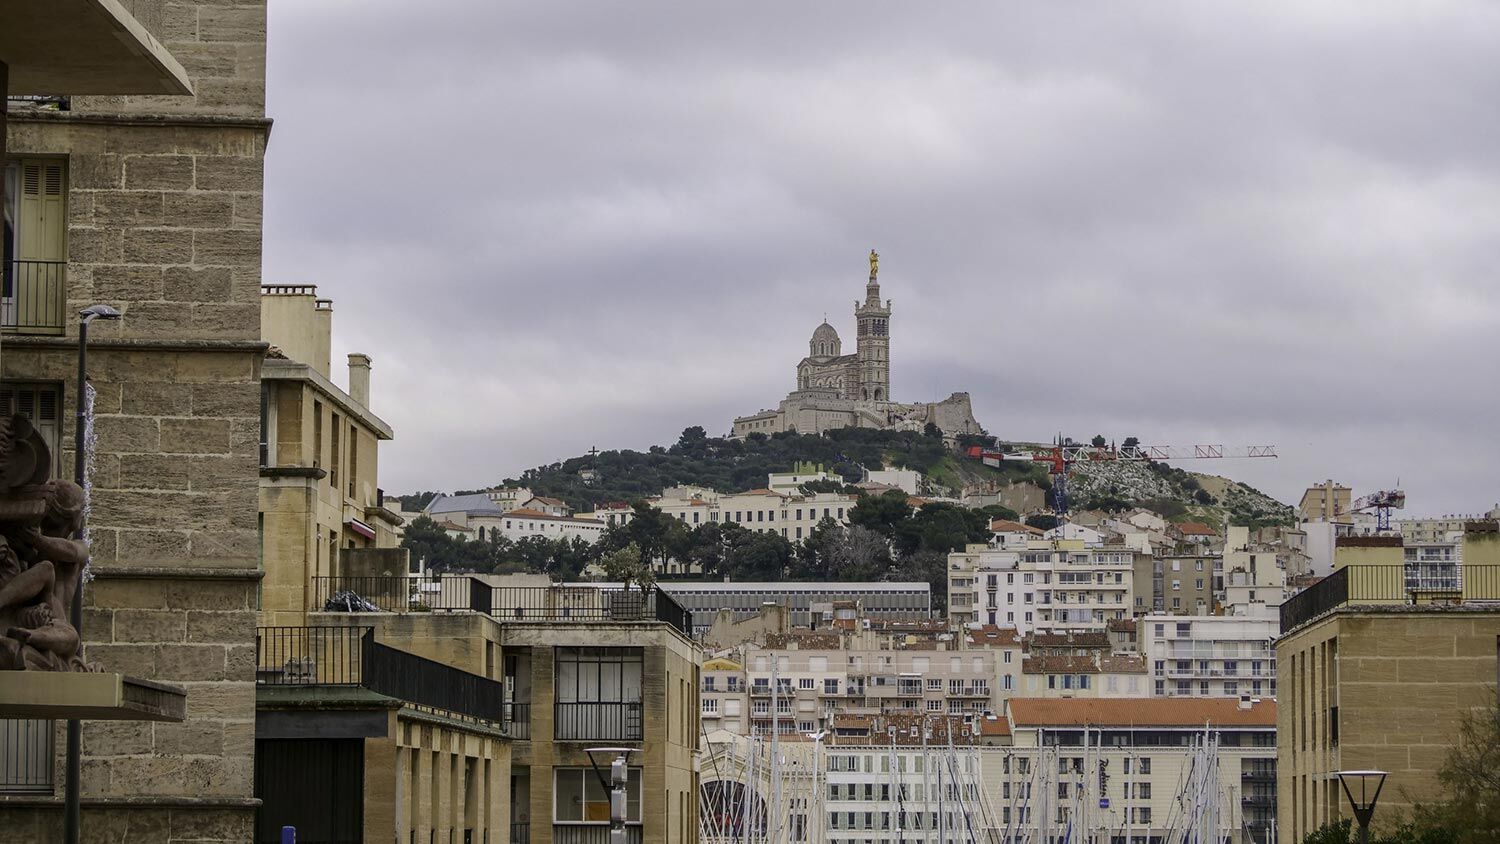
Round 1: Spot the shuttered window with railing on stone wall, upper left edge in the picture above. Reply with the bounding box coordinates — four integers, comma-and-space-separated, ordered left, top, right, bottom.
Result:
0, 159, 68, 334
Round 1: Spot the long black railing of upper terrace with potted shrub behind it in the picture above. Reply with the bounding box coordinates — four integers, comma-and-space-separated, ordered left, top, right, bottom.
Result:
314, 574, 693, 636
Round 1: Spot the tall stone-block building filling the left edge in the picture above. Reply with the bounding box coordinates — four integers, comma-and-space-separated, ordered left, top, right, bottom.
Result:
0, 0, 270, 841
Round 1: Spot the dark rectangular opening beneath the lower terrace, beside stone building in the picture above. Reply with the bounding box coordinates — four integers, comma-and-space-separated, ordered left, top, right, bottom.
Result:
255, 739, 365, 844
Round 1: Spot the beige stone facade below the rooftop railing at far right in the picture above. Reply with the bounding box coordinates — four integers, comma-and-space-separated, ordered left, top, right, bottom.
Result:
1277, 606, 1500, 841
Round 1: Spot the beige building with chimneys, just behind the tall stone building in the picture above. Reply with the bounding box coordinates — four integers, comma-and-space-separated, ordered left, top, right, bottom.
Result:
260, 285, 407, 625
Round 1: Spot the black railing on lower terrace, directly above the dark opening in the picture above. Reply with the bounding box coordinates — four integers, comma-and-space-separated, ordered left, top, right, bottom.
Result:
255, 627, 515, 723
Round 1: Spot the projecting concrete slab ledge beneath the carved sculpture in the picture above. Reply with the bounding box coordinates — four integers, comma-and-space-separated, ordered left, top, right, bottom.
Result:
0, 672, 188, 721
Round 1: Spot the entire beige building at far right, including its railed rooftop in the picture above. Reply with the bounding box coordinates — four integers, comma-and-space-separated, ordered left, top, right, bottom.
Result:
1277, 522, 1500, 841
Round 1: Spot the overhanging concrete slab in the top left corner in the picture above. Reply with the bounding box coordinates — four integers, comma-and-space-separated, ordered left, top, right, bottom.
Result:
0, 0, 192, 94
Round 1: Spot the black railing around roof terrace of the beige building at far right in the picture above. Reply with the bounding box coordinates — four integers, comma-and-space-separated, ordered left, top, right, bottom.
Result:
1281, 562, 1500, 633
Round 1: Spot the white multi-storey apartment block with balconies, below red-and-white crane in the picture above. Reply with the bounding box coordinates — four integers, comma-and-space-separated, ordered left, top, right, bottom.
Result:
948, 540, 1136, 636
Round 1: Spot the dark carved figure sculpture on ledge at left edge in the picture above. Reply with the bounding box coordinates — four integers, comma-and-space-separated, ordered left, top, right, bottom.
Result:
0, 415, 95, 672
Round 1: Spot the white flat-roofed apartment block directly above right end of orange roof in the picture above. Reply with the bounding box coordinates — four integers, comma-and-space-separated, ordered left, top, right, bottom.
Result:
1137, 613, 1281, 699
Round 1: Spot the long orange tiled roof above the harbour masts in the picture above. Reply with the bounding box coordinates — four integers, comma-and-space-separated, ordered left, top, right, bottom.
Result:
1008, 697, 1277, 729
